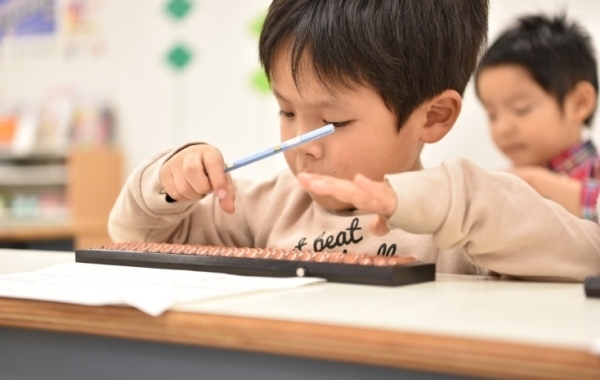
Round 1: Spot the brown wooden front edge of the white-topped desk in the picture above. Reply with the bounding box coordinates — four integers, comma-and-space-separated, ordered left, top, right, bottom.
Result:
0, 298, 600, 379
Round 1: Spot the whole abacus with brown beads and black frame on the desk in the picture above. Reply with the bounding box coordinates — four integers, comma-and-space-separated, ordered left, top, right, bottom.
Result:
75, 242, 435, 286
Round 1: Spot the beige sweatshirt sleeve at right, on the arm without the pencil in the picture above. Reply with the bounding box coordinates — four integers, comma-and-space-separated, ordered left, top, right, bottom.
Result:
386, 159, 600, 281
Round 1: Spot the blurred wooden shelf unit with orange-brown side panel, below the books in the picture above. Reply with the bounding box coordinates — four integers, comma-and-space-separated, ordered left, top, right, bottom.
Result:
0, 147, 123, 249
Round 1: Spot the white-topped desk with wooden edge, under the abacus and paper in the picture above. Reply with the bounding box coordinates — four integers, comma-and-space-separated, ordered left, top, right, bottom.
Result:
0, 250, 600, 379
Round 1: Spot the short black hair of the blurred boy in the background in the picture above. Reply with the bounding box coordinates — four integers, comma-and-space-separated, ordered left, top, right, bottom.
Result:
475, 13, 598, 126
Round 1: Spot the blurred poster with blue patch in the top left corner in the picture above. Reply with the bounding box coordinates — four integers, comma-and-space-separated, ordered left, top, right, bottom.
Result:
0, 0, 58, 59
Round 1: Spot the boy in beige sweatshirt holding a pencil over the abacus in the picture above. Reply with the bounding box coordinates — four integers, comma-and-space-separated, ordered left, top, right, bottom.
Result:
109, 0, 600, 281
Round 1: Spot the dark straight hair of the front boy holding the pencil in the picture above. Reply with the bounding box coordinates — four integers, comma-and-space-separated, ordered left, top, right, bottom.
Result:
259, 0, 489, 128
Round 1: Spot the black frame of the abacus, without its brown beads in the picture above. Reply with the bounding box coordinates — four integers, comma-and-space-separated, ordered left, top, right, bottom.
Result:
75, 249, 435, 286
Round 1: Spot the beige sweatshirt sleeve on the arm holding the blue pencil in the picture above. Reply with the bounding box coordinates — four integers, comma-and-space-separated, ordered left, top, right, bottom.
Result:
108, 148, 268, 247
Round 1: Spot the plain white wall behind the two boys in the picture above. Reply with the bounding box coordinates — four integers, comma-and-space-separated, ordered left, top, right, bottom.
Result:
0, 0, 600, 178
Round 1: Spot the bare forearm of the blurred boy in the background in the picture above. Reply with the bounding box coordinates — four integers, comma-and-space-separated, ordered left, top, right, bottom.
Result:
510, 165, 583, 218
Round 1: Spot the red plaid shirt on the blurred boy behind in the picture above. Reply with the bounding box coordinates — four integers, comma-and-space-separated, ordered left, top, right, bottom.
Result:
548, 141, 600, 222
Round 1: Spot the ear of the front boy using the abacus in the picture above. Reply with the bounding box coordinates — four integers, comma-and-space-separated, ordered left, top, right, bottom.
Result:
421, 90, 462, 144
